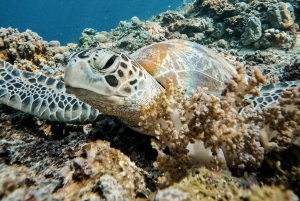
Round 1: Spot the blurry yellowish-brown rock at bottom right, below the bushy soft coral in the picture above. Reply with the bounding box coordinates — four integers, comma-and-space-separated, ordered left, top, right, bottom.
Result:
155, 168, 298, 201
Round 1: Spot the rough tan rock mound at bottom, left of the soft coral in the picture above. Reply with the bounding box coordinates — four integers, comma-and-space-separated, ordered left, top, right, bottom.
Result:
56, 141, 147, 200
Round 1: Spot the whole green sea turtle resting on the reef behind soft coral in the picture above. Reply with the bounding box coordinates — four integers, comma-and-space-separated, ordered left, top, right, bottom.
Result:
0, 40, 295, 131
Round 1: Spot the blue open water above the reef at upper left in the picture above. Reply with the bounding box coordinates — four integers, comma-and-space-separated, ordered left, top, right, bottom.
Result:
0, 0, 182, 45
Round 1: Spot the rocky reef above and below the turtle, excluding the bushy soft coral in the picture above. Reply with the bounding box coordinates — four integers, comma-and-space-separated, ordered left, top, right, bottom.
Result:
0, 0, 300, 200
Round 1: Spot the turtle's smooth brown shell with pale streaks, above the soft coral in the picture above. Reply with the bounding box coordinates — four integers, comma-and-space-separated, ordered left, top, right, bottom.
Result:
131, 39, 236, 94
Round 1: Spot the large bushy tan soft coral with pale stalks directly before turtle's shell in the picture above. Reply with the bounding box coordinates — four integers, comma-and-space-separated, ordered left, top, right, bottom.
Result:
140, 67, 266, 185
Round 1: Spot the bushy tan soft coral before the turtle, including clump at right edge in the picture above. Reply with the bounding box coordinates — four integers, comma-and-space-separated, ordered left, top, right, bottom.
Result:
139, 66, 300, 186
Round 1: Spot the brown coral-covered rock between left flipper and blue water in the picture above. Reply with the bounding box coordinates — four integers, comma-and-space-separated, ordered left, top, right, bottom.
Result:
0, 28, 73, 78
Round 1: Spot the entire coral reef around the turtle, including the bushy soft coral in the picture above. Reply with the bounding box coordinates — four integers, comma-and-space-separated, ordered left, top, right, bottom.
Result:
0, 0, 300, 201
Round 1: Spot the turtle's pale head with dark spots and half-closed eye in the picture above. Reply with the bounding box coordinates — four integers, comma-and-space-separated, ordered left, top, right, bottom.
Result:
65, 48, 156, 110
